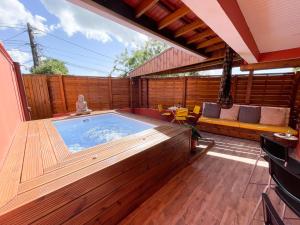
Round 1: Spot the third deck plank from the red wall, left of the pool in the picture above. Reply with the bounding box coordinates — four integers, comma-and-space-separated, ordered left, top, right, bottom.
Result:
38, 121, 57, 172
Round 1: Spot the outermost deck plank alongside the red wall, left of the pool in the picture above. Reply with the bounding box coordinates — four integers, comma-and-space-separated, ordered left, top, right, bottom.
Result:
0, 123, 28, 207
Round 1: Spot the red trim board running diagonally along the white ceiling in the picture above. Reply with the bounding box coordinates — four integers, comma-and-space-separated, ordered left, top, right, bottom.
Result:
218, 0, 259, 60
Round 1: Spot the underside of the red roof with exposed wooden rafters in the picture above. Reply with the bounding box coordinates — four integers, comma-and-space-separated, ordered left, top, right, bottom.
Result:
82, 0, 223, 58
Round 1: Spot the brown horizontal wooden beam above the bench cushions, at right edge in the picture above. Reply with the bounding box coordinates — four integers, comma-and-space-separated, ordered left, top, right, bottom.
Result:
240, 59, 300, 71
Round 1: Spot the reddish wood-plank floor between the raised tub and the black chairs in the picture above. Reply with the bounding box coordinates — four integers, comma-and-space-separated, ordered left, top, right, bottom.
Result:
120, 133, 300, 225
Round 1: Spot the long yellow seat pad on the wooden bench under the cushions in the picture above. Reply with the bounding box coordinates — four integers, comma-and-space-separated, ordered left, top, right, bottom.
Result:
198, 116, 298, 135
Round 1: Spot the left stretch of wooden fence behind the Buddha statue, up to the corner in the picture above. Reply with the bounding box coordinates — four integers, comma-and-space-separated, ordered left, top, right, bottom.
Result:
23, 74, 130, 119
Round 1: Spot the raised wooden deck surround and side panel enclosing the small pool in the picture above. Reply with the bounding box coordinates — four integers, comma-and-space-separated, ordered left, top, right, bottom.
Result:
0, 111, 191, 225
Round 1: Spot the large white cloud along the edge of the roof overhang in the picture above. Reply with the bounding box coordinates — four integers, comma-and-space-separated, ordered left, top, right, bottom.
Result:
41, 0, 148, 47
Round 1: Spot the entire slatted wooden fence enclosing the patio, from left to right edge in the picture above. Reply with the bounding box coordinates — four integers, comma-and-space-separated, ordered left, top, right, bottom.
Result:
23, 73, 300, 125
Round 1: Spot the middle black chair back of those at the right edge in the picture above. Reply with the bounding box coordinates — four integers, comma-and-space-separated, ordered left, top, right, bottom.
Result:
269, 157, 300, 217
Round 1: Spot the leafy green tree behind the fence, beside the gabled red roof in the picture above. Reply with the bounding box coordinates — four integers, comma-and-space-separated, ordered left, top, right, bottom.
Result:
111, 39, 168, 76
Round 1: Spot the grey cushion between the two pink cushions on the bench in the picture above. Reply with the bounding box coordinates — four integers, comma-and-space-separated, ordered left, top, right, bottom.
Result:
239, 106, 261, 123
